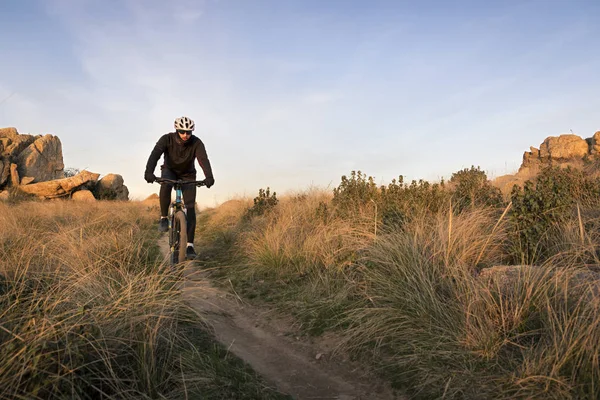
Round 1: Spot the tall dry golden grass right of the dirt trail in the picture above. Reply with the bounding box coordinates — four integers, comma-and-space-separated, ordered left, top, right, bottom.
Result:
203, 188, 600, 399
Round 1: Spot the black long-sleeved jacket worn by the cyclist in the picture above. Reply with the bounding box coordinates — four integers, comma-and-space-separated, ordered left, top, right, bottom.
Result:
146, 132, 214, 179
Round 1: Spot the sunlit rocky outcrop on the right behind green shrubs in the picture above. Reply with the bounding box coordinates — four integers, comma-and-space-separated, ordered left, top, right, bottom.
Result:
493, 131, 600, 194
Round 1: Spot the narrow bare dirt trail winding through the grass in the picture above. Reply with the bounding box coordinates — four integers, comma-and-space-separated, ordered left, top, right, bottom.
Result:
160, 239, 402, 400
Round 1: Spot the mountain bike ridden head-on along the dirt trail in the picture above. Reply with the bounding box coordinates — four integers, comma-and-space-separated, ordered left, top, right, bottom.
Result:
156, 178, 206, 267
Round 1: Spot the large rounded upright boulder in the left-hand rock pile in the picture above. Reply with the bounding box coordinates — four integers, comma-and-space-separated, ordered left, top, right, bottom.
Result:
16, 135, 65, 182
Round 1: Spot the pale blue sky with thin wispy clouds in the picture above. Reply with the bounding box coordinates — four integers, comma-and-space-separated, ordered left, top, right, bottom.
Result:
0, 0, 600, 205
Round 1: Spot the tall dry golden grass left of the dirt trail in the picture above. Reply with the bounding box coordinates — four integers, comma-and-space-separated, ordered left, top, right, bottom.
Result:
0, 201, 290, 399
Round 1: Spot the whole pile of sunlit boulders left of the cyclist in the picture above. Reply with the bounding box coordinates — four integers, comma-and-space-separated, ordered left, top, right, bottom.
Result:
0, 128, 129, 200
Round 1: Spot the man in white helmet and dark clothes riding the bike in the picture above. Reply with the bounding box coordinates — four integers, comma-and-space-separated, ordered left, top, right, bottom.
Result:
144, 117, 215, 259
